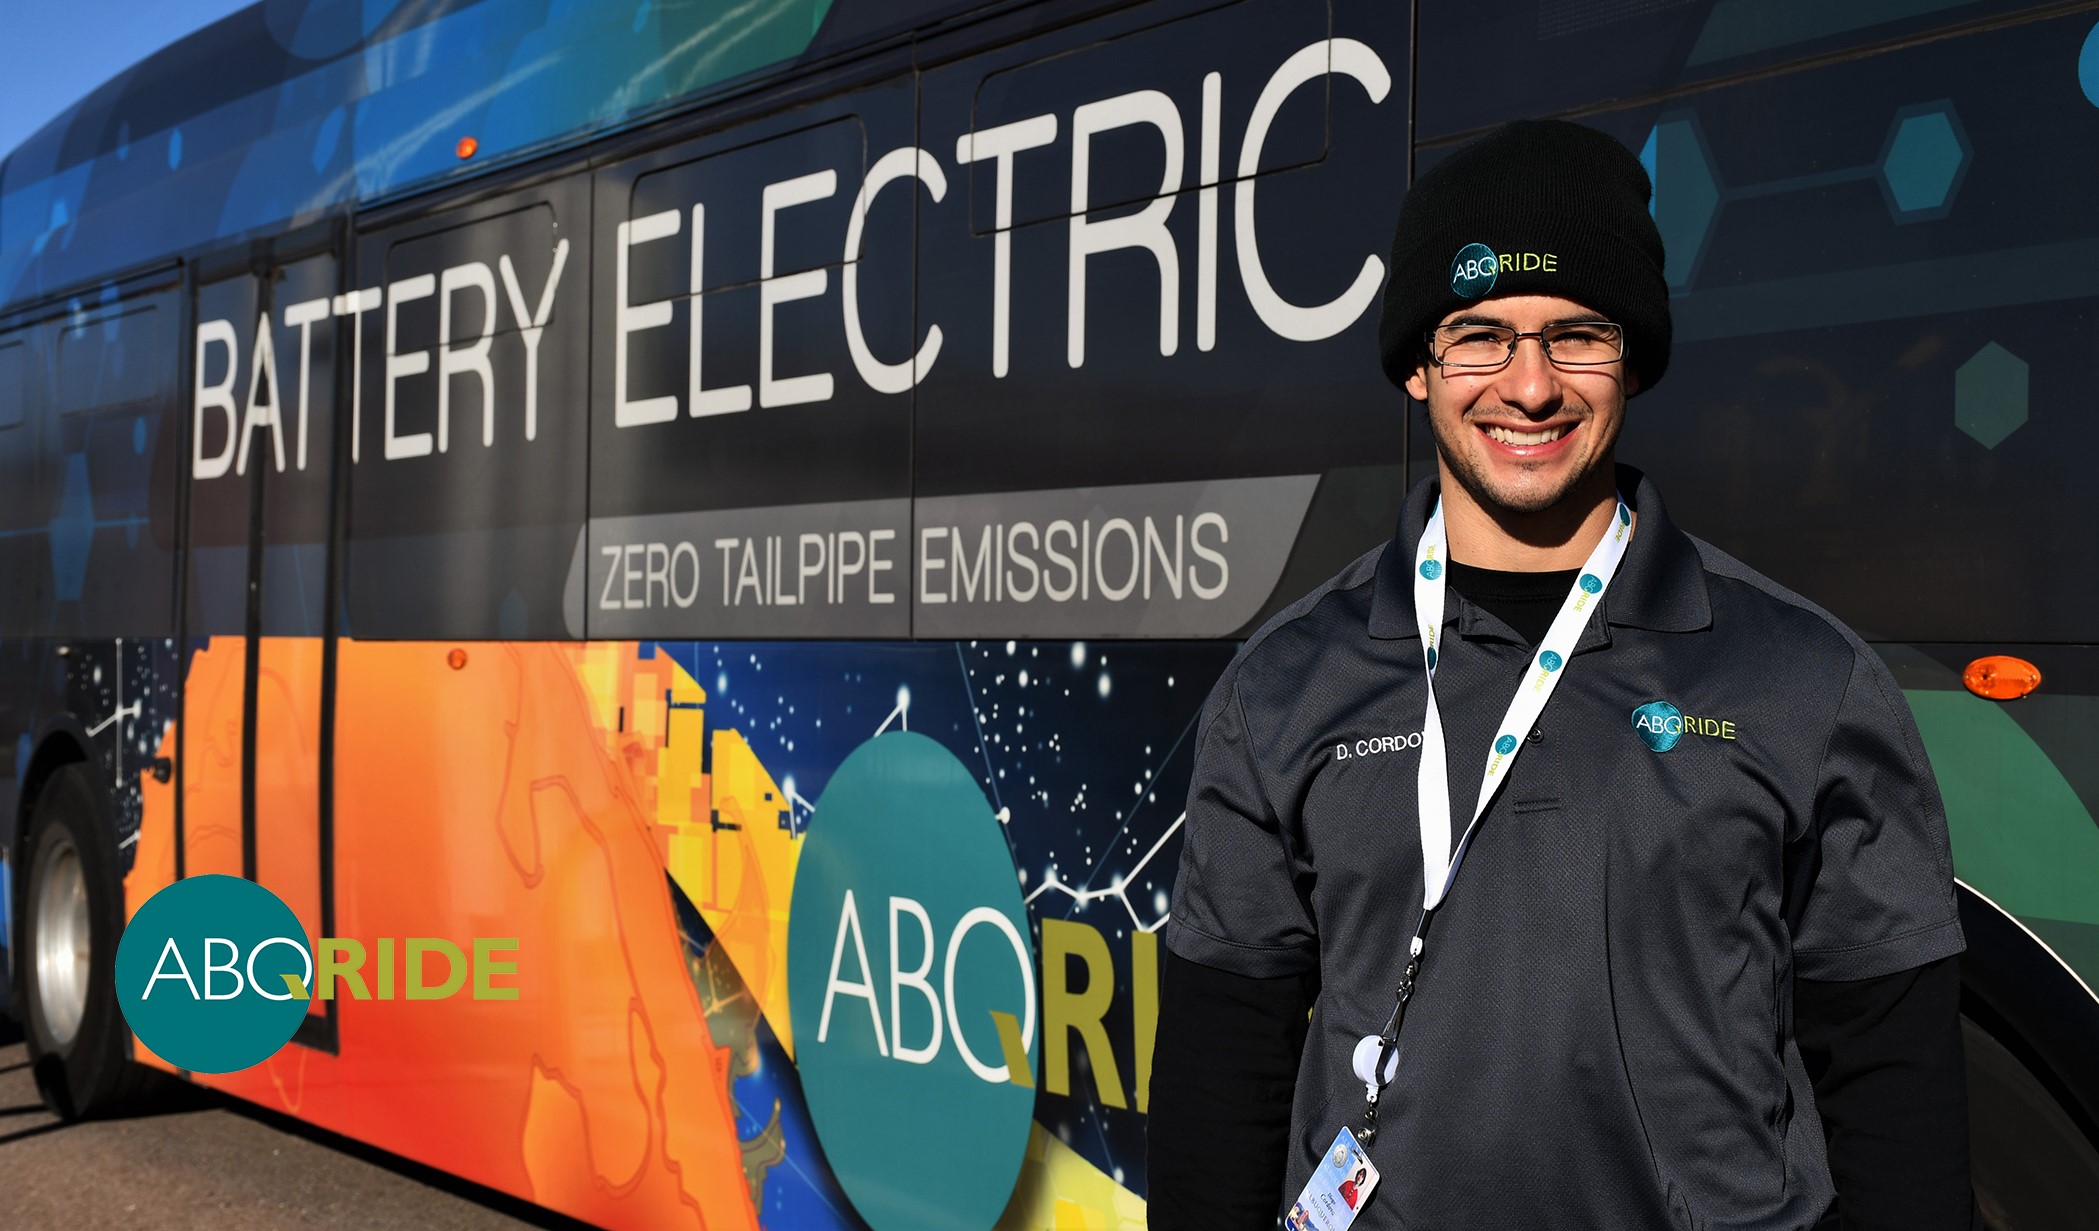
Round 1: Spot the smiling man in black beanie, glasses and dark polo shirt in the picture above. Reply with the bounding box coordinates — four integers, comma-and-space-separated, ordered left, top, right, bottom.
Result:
1150, 122, 1973, 1231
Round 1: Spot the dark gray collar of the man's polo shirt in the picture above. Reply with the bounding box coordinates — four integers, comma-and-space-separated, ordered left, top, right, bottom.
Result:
1371, 457, 1713, 643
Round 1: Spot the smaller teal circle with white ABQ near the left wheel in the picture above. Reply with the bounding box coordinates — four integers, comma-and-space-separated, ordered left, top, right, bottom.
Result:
118, 876, 313, 1073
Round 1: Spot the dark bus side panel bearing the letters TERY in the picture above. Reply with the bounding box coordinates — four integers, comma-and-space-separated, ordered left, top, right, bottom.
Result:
336, 176, 590, 639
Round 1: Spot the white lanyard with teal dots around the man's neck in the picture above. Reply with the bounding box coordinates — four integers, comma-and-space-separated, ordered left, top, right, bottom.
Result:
1352, 496, 1633, 1145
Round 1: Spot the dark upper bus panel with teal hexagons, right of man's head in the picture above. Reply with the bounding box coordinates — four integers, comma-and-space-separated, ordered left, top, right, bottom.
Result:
1511, 13, 2099, 643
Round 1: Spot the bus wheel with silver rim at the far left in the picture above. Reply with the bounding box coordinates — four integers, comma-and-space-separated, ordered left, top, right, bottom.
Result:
19, 765, 157, 1120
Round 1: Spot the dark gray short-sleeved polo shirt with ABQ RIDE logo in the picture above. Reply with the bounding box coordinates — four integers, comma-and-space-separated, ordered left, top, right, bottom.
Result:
1167, 466, 1963, 1231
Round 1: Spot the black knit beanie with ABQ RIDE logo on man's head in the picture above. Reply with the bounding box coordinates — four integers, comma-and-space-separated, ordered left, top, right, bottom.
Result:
1377, 120, 1669, 391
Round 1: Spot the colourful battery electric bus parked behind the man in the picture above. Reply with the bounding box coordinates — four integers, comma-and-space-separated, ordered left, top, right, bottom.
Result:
0, 0, 2099, 1231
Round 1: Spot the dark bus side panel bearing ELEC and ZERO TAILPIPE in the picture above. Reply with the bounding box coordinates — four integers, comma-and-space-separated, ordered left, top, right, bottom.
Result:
591, 80, 919, 637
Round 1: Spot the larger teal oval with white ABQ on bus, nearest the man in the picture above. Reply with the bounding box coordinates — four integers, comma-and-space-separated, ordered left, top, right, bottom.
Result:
787, 731, 1037, 1231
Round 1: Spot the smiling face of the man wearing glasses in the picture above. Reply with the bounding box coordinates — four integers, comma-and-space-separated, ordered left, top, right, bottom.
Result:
1406, 294, 1639, 513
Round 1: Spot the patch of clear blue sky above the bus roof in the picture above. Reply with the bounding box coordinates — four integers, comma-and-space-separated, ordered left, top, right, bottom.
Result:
0, 0, 252, 158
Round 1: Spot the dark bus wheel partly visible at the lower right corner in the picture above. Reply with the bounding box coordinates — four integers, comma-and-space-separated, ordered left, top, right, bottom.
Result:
1960, 1017, 2099, 1231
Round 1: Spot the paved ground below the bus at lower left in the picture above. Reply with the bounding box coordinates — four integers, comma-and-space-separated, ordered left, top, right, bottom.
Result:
0, 1017, 584, 1231
